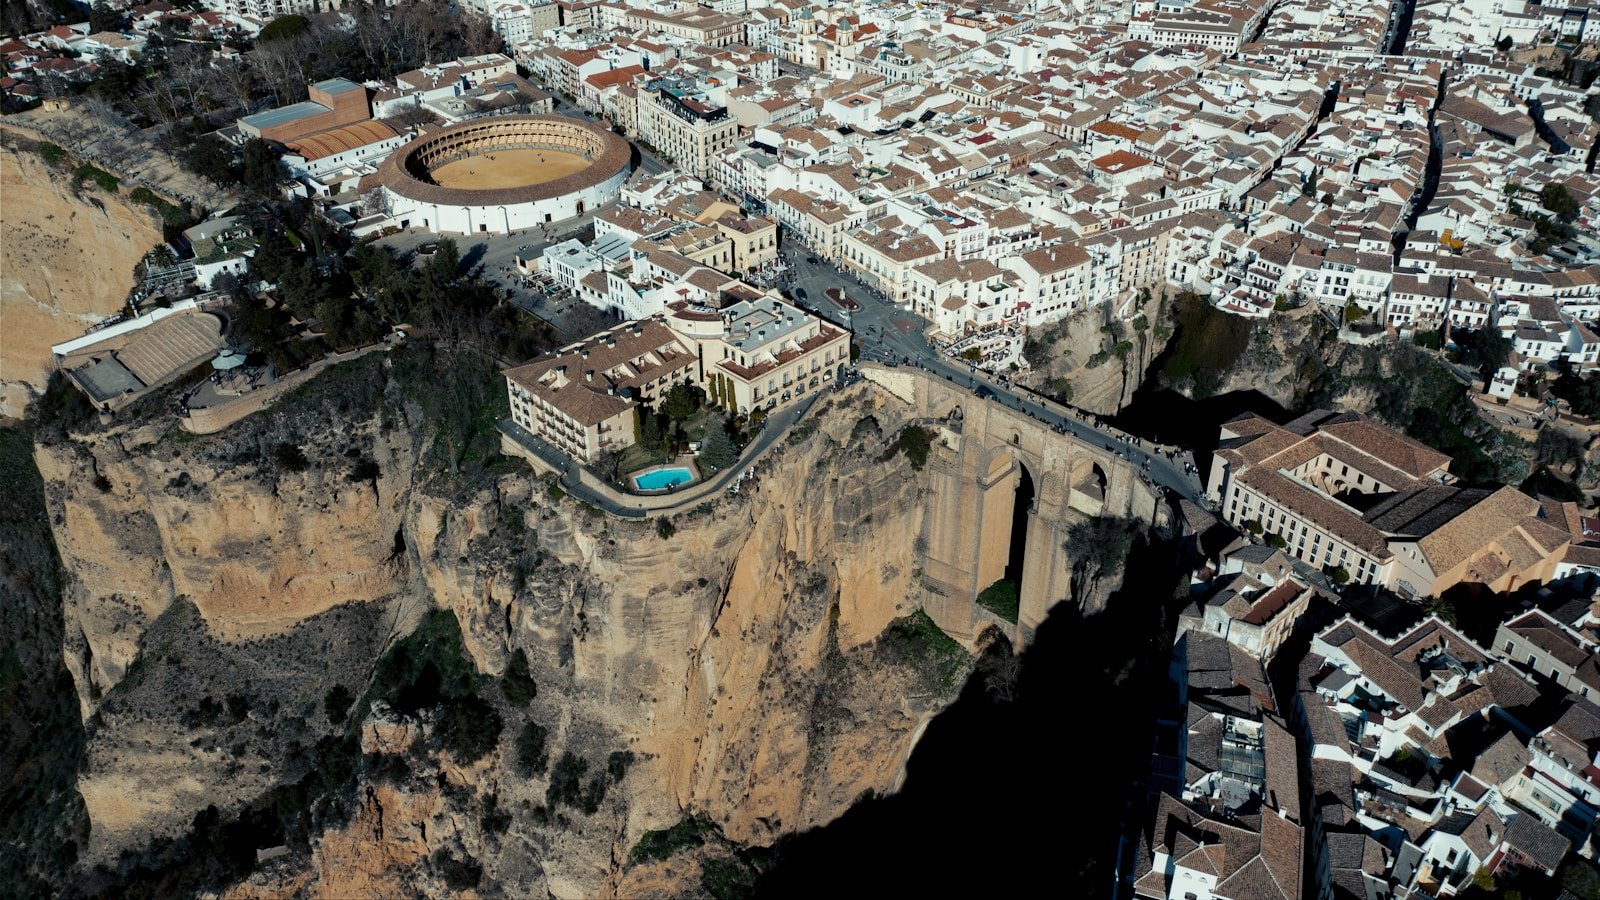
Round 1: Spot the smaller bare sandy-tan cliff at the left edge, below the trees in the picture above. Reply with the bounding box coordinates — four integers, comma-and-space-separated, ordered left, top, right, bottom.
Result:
0, 144, 162, 416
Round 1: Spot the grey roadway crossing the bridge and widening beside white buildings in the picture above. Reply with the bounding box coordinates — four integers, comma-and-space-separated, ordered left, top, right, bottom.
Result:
782, 241, 1205, 506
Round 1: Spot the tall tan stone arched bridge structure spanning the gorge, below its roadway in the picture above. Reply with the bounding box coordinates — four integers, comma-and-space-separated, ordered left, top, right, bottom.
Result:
862, 365, 1166, 650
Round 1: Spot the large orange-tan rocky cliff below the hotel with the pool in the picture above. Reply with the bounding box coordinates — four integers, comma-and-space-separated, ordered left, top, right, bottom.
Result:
38, 353, 952, 897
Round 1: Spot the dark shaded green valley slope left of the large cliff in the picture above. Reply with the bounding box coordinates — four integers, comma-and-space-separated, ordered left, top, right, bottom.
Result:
0, 428, 88, 897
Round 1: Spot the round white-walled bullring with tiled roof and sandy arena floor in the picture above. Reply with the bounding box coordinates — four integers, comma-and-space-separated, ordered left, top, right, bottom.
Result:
378, 115, 634, 234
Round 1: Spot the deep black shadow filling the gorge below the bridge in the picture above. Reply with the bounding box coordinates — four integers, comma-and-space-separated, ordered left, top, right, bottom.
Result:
755, 528, 1178, 897
